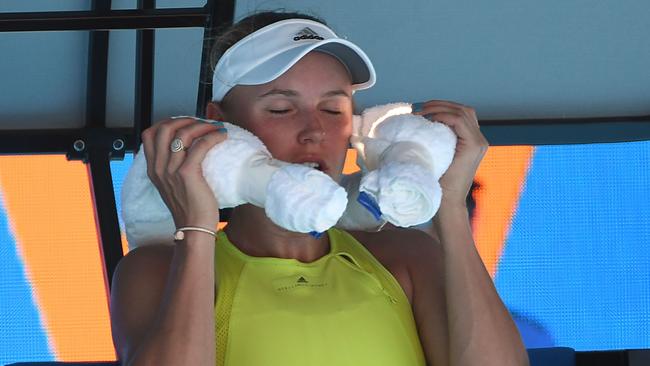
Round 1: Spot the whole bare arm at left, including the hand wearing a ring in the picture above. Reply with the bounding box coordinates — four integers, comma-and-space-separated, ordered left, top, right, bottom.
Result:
111, 119, 225, 366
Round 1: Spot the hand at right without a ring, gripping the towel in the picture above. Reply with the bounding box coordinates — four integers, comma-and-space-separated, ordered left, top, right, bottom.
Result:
413, 100, 488, 206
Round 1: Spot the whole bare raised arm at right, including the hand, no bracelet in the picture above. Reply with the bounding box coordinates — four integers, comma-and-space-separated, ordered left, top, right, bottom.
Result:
414, 101, 528, 366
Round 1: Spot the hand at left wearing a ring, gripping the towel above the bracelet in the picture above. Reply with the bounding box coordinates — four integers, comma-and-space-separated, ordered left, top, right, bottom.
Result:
142, 118, 227, 229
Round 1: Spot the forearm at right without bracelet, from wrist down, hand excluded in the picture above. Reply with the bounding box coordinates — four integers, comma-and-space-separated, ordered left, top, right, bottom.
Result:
434, 200, 528, 366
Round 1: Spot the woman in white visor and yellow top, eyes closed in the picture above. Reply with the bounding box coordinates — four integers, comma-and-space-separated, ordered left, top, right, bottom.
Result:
111, 13, 528, 365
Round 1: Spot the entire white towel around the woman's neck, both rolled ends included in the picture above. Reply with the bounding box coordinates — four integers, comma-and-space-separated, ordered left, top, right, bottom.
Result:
122, 103, 456, 247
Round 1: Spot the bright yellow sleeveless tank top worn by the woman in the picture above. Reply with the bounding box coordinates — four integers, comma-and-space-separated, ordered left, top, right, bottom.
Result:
215, 229, 425, 366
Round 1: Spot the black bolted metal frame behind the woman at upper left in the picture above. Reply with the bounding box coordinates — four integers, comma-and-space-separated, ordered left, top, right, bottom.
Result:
0, 0, 234, 287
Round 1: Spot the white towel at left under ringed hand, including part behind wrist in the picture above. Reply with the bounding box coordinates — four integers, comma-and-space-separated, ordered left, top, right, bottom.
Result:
122, 123, 347, 247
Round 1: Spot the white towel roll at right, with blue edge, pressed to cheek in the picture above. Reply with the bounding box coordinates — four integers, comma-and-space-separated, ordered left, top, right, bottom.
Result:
350, 103, 456, 226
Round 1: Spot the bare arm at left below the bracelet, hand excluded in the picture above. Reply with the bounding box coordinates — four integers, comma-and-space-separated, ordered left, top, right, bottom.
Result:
111, 234, 215, 365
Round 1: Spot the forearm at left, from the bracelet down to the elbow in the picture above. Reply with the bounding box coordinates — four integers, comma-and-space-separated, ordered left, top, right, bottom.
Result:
128, 232, 216, 366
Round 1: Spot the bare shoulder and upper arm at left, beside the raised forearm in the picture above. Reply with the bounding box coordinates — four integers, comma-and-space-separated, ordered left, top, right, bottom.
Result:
111, 245, 174, 359
